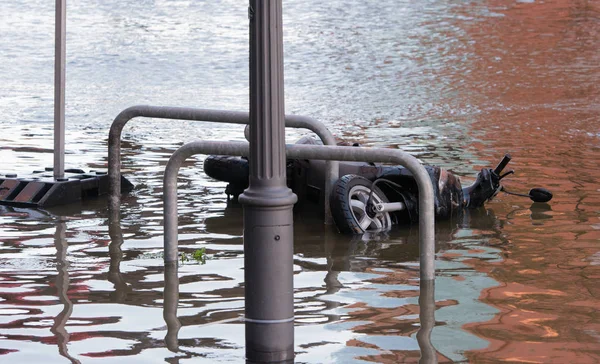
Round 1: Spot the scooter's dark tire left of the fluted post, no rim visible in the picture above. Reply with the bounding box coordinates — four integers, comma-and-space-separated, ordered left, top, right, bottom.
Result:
204, 155, 250, 188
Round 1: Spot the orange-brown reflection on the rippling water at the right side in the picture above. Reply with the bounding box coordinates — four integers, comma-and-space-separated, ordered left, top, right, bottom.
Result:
454, 0, 600, 363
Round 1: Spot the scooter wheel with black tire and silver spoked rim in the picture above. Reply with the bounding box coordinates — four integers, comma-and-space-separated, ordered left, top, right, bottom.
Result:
329, 174, 392, 234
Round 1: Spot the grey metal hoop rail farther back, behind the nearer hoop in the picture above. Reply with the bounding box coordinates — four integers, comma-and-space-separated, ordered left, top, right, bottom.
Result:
108, 105, 339, 224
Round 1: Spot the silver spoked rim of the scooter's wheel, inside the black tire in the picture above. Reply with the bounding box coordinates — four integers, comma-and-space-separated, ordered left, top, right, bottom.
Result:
348, 185, 392, 231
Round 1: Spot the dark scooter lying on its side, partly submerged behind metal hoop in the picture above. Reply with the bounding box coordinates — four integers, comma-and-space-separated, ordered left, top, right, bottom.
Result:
204, 137, 552, 234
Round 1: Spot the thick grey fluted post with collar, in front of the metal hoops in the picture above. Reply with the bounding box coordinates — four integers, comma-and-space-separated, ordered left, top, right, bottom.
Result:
239, 0, 297, 363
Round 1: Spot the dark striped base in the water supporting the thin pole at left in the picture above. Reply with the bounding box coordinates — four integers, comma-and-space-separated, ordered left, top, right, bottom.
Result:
0, 168, 133, 208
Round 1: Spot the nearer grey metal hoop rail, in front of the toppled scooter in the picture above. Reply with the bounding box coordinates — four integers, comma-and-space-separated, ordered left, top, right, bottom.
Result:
163, 141, 435, 281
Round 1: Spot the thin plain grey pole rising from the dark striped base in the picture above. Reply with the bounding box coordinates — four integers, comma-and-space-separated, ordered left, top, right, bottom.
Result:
54, 0, 67, 179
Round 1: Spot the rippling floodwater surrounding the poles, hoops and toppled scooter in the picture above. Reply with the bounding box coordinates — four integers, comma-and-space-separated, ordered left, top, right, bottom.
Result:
0, 0, 600, 363
